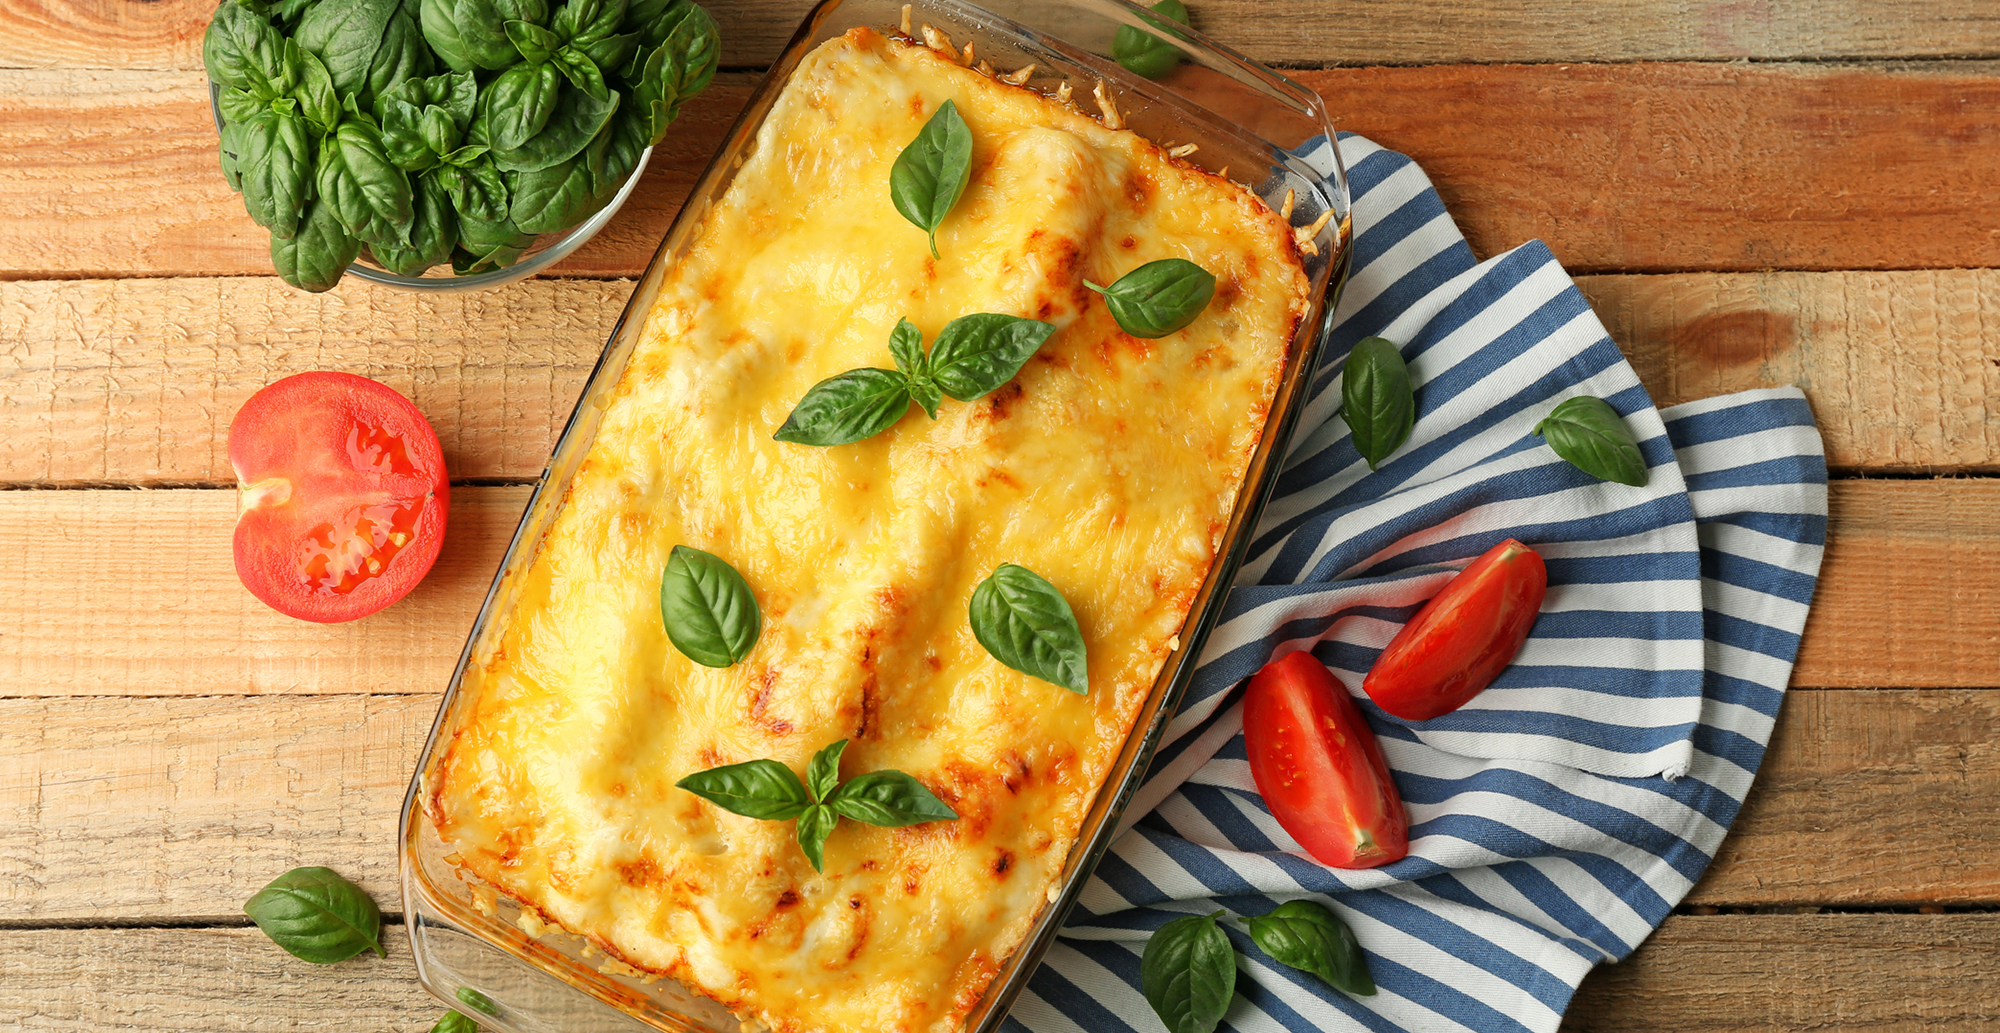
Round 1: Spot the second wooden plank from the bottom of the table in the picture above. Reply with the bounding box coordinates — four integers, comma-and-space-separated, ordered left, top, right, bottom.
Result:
0, 689, 2000, 923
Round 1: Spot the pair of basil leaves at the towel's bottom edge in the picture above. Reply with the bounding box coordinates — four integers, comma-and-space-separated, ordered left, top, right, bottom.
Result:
1138, 901, 1376, 1033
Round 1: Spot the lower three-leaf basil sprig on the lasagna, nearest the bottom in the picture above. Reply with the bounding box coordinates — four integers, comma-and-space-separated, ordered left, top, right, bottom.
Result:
674, 739, 958, 871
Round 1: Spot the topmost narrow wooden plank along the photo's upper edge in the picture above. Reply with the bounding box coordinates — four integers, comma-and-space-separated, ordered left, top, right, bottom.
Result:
0, 0, 2000, 68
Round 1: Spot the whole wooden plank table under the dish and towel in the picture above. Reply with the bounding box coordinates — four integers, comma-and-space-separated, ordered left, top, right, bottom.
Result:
0, 0, 2000, 1033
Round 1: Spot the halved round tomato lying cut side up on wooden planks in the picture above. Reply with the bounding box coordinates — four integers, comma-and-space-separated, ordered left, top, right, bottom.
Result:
230, 372, 450, 625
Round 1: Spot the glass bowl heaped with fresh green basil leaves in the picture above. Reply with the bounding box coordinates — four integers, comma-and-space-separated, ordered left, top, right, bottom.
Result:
202, 0, 718, 290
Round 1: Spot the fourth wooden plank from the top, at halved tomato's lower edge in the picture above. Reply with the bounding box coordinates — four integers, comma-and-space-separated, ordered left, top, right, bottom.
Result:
0, 480, 1976, 697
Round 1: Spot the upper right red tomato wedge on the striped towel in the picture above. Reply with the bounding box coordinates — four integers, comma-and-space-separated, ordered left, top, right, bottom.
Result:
1362, 539, 1548, 721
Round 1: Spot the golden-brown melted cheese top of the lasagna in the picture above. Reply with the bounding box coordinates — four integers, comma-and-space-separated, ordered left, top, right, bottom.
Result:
430, 30, 1306, 1033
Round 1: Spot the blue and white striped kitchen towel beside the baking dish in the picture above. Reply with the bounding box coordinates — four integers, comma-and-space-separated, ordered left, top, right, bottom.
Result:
1008, 136, 1826, 1033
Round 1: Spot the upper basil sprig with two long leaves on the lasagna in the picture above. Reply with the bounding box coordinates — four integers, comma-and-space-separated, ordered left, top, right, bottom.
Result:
772, 312, 1056, 446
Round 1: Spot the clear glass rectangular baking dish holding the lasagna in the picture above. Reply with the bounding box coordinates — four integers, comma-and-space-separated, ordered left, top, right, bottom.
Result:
400, 0, 1350, 1033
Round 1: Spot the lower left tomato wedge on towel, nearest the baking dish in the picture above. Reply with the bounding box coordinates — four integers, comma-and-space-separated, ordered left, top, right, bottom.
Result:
1244, 651, 1410, 869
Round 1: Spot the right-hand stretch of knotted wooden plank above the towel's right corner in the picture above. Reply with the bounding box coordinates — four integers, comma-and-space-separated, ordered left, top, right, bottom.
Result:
1578, 268, 2000, 472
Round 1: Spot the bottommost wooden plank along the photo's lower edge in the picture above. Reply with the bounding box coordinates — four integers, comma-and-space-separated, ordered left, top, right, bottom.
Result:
0, 915, 2000, 1033
